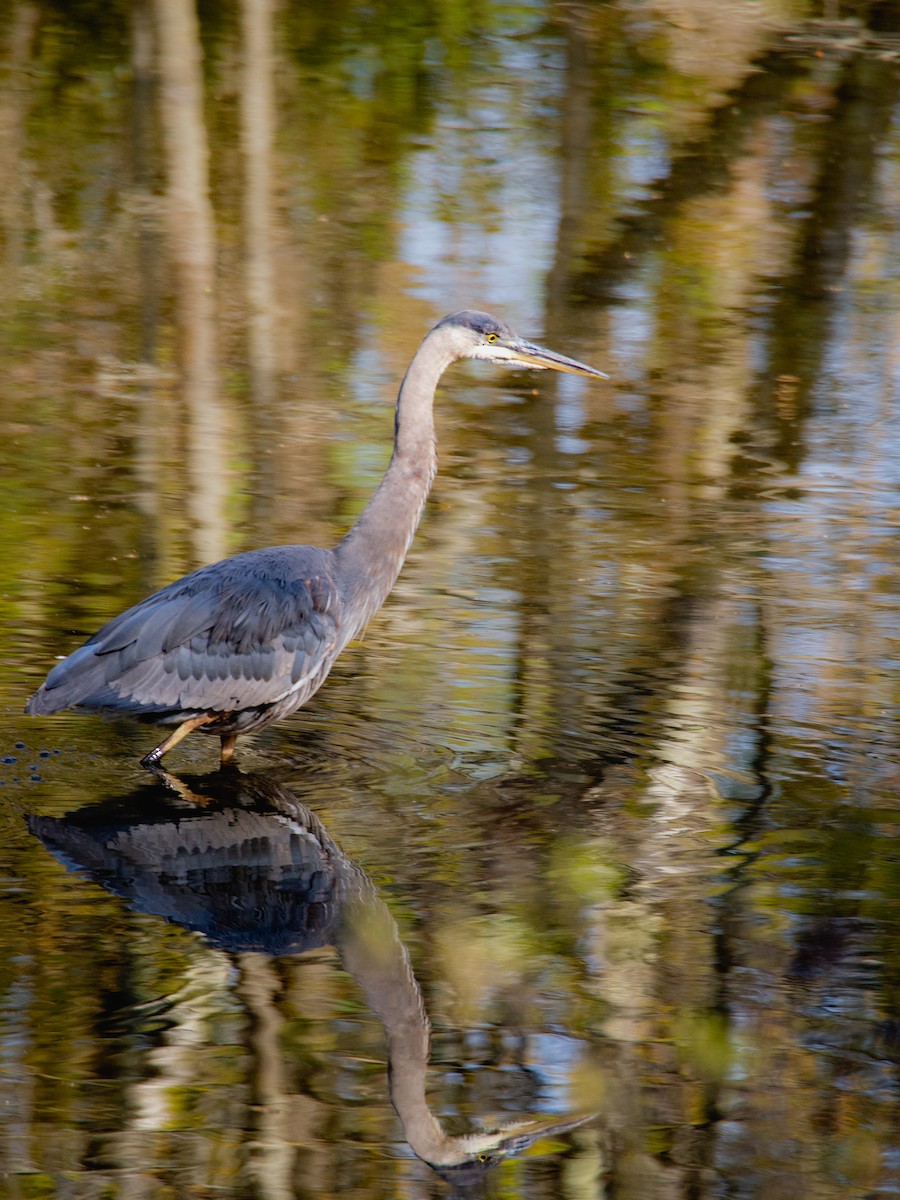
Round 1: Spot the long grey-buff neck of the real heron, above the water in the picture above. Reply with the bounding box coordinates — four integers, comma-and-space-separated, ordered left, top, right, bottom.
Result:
335, 334, 456, 632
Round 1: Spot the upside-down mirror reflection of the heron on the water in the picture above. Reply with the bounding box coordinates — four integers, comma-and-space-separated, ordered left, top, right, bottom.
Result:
29, 768, 593, 1187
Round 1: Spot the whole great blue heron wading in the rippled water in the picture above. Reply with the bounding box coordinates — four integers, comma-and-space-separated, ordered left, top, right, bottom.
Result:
25, 312, 606, 767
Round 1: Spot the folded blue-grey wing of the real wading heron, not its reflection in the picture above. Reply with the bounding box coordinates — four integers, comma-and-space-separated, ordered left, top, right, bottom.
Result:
31, 546, 343, 713
